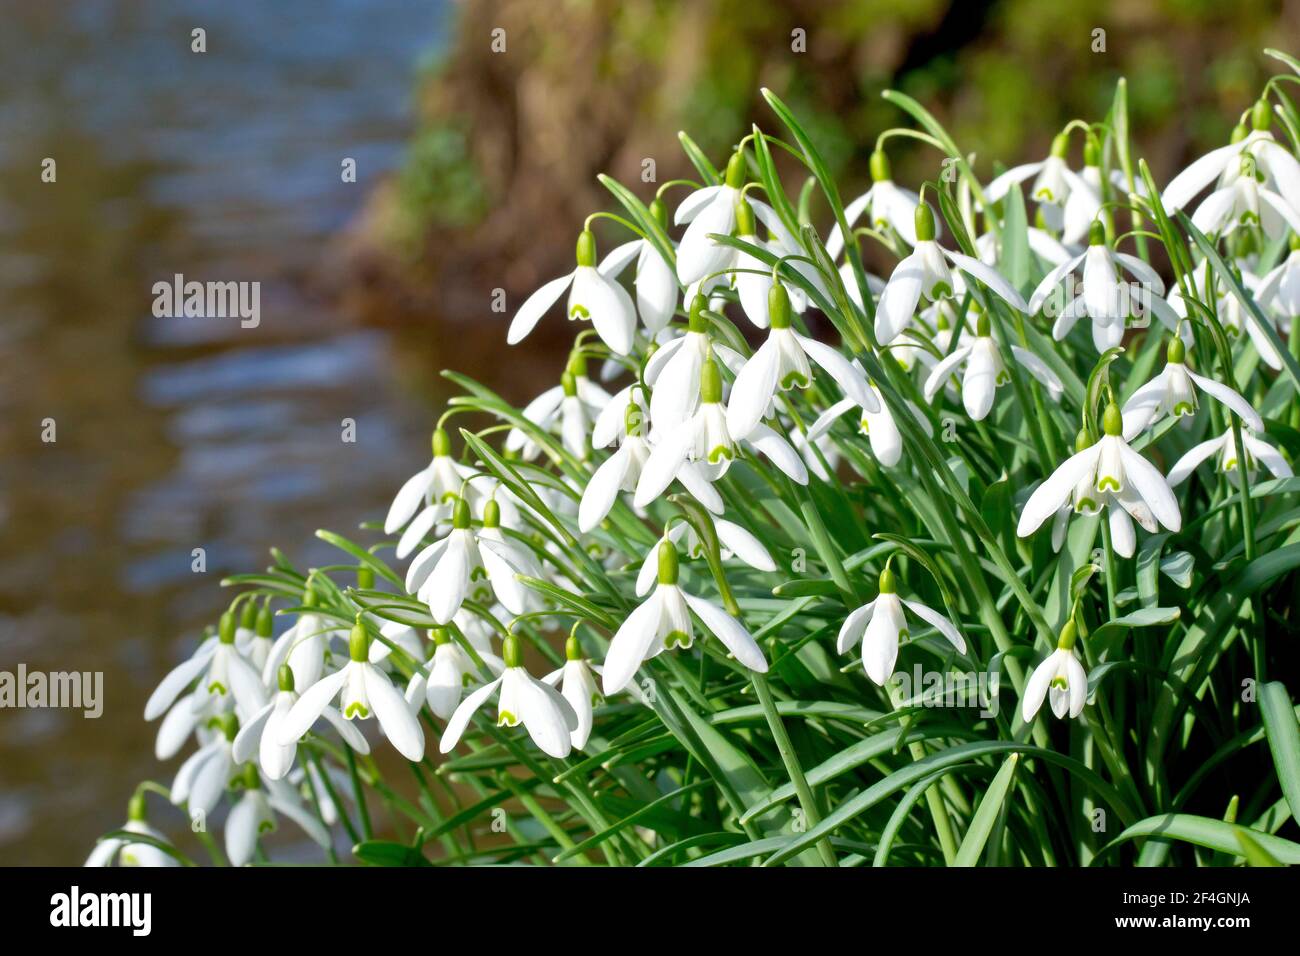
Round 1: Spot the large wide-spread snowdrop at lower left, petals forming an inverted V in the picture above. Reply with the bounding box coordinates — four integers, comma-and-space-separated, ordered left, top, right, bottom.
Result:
274, 615, 424, 761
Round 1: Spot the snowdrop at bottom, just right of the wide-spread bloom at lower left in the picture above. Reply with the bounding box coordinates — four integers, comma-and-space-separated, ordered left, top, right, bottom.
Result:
438, 635, 577, 758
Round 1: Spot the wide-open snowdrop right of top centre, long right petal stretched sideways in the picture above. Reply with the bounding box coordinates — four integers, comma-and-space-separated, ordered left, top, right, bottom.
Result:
876, 203, 1026, 345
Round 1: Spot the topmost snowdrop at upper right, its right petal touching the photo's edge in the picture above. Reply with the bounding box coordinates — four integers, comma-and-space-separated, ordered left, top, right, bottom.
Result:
1160, 99, 1300, 219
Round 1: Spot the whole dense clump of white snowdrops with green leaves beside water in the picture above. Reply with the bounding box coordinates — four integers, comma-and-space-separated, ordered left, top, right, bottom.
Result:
91, 59, 1300, 865
